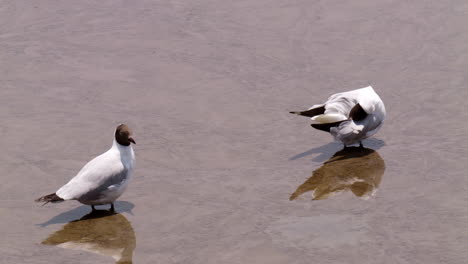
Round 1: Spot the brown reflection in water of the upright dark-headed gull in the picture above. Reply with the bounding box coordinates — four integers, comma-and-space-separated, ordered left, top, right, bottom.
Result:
42, 210, 136, 264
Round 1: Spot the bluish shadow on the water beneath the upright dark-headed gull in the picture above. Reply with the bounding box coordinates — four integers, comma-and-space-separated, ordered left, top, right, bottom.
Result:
37, 201, 135, 227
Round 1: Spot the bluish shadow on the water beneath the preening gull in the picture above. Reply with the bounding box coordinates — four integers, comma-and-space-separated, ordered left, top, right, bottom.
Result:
289, 138, 385, 162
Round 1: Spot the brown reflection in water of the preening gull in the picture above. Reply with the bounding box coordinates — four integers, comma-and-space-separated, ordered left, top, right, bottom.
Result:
289, 147, 385, 200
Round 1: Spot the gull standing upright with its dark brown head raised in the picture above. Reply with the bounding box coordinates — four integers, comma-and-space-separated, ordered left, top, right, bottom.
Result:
36, 124, 136, 211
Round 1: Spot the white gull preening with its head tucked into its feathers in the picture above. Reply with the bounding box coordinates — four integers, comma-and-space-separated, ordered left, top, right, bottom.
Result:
290, 86, 386, 147
